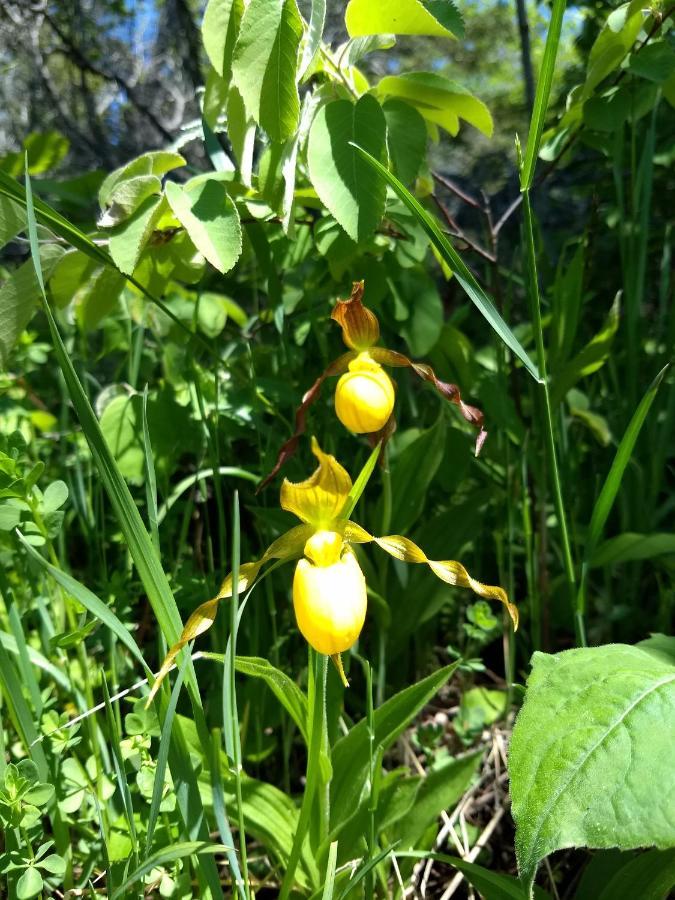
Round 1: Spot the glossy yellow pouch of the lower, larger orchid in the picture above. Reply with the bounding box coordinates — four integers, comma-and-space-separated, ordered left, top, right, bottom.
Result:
293, 549, 366, 656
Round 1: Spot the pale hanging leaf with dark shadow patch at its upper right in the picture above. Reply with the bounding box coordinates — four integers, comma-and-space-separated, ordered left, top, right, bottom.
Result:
165, 179, 241, 272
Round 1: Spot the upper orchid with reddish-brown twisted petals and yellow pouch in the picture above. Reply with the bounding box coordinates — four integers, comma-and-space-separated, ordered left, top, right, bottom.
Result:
258, 281, 487, 491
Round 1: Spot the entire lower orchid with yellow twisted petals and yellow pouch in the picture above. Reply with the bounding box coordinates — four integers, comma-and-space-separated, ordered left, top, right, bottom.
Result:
148, 438, 518, 704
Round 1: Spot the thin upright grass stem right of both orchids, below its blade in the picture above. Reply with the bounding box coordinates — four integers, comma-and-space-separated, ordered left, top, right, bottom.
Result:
523, 190, 586, 647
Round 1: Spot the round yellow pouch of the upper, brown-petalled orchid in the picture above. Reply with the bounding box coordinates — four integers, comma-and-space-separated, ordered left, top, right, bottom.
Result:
335, 352, 396, 434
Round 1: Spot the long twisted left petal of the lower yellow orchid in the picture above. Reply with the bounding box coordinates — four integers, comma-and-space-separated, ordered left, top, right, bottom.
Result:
145, 525, 313, 709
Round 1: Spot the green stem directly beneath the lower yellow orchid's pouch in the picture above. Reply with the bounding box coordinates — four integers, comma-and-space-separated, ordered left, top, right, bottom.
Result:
279, 647, 328, 900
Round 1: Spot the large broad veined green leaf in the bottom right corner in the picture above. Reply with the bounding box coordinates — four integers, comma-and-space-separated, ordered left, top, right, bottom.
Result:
509, 644, 675, 886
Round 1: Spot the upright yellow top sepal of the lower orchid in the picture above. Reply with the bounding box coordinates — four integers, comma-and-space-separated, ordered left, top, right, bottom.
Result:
281, 438, 352, 528
